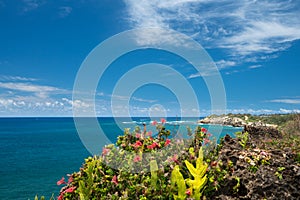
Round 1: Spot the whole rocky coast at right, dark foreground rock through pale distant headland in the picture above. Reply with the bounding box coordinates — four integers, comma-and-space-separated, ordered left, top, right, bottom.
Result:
201, 115, 300, 200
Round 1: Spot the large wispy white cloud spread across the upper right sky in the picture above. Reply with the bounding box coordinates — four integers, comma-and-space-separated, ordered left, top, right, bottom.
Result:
124, 0, 300, 62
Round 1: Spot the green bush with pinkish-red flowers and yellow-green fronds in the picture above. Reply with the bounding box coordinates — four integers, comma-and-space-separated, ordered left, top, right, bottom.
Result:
57, 119, 213, 199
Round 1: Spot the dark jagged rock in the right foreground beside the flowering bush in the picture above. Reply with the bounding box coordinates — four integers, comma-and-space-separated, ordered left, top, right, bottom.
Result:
207, 135, 300, 200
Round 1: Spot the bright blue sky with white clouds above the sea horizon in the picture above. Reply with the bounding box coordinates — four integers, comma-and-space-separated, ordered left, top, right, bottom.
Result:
0, 0, 300, 116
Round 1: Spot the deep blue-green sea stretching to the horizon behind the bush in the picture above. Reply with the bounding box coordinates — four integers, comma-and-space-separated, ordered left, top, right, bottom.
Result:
0, 117, 241, 200
